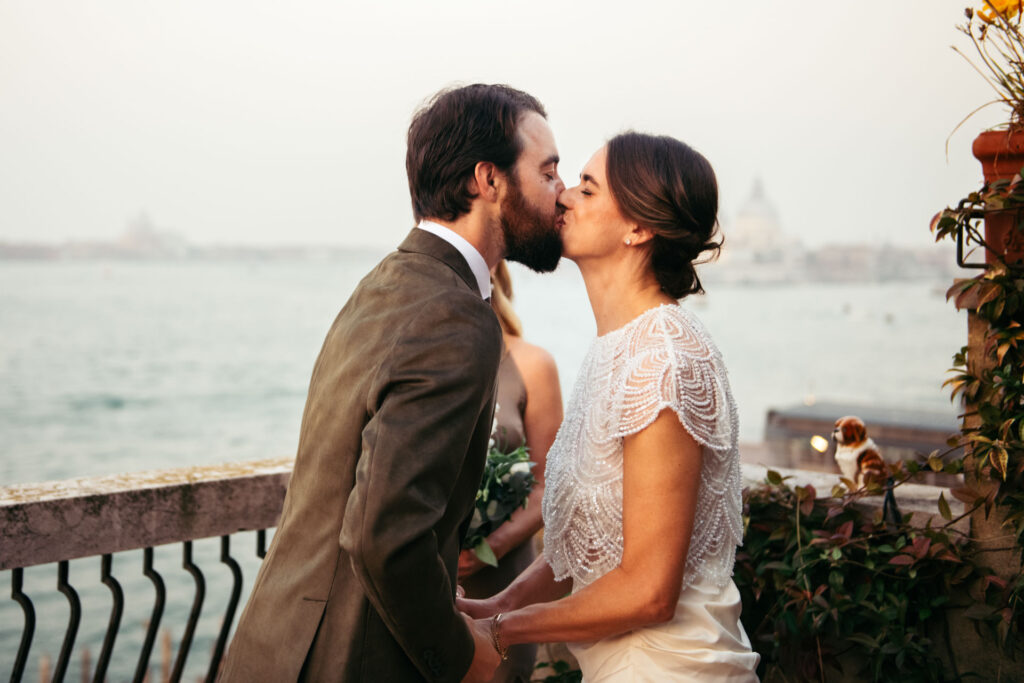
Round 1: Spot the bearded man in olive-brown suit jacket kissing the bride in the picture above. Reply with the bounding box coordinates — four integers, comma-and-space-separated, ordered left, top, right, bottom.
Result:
220, 85, 564, 682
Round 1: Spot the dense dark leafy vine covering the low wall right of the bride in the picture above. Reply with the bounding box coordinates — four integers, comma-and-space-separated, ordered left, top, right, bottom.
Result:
733, 471, 1006, 681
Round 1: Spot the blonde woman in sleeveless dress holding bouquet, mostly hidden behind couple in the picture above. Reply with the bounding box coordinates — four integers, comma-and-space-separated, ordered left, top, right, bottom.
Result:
459, 261, 562, 683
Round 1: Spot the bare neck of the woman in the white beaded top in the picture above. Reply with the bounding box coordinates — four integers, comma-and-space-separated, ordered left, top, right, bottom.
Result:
577, 255, 675, 336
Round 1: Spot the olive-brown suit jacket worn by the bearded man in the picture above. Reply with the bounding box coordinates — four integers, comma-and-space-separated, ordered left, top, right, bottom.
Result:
220, 228, 502, 682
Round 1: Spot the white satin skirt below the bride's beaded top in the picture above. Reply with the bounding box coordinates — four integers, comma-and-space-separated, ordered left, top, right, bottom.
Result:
569, 581, 761, 683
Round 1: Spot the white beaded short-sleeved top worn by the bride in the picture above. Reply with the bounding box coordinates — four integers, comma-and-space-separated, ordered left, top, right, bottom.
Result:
543, 304, 742, 591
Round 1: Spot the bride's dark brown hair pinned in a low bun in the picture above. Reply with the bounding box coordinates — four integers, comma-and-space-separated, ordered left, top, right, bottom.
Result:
607, 131, 722, 299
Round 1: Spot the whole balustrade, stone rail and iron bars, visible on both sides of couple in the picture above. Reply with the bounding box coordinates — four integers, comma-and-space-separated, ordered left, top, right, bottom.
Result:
0, 458, 967, 680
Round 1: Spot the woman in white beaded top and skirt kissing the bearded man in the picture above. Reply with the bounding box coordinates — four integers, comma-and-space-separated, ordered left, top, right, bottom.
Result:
459, 132, 759, 683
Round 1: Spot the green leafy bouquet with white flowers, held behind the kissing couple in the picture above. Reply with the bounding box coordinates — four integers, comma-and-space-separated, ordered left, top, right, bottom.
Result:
462, 445, 537, 566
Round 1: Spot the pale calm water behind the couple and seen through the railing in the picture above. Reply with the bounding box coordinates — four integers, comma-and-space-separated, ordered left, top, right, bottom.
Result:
0, 254, 967, 680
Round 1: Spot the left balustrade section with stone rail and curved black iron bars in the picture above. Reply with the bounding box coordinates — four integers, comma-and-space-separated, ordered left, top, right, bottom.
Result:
0, 459, 291, 681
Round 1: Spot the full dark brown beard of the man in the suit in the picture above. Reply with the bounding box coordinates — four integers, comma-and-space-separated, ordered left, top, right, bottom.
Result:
499, 180, 562, 272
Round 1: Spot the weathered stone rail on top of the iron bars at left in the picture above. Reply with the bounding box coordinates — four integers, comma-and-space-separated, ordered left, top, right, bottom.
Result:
0, 458, 292, 569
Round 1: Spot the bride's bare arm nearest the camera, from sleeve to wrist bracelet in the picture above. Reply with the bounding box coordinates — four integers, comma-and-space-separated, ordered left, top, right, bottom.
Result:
489, 409, 700, 645
